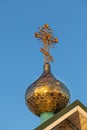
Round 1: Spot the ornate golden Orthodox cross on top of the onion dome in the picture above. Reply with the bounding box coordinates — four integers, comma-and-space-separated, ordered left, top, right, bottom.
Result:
35, 24, 58, 64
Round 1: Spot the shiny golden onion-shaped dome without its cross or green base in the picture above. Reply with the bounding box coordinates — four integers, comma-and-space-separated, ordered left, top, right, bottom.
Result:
25, 63, 70, 116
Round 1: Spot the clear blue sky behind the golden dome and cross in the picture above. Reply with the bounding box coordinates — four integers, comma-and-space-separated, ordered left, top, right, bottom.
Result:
0, 0, 87, 130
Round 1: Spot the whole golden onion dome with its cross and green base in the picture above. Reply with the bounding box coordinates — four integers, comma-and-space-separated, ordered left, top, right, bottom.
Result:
25, 24, 70, 123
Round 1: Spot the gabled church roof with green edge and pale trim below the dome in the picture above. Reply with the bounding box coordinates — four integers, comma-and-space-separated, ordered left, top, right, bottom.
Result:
34, 100, 87, 130
